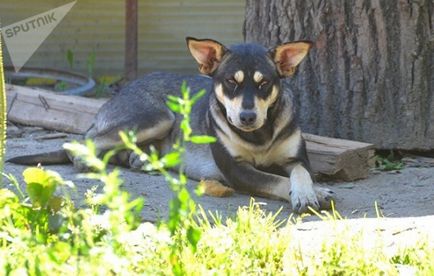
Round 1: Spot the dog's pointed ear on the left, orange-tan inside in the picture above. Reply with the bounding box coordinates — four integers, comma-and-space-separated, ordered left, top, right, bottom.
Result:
185, 37, 228, 75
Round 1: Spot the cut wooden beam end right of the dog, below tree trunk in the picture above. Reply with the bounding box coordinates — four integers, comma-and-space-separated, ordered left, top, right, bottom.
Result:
303, 133, 375, 181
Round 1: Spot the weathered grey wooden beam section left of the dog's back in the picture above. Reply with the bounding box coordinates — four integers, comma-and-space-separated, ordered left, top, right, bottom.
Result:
6, 85, 106, 134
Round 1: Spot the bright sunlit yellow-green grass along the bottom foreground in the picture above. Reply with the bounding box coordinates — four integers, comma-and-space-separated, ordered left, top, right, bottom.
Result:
0, 196, 434, 275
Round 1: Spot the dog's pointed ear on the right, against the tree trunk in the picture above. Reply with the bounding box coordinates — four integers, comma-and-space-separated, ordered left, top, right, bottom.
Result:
269, 41, 313, 78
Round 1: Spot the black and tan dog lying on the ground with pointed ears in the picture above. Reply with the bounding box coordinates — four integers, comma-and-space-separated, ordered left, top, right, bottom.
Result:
9, 37, 332, 213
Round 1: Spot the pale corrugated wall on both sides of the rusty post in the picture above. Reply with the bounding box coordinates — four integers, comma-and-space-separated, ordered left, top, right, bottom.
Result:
0, 0, 245, 74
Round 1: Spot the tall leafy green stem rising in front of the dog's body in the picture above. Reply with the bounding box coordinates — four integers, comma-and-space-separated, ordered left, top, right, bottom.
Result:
121, 82, 216, 275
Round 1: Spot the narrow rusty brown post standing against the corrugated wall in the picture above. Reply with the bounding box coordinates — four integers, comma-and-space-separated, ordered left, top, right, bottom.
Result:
125, 0, 138, 80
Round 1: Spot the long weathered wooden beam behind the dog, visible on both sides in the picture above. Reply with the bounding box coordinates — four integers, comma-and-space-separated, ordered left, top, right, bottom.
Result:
6, 85, 374, 181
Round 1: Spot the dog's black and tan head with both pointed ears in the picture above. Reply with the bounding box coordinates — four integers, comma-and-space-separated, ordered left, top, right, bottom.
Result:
187, 37, 312, 132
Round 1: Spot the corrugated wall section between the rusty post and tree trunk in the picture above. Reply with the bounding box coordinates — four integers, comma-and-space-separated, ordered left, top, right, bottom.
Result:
139, 0, 245, 72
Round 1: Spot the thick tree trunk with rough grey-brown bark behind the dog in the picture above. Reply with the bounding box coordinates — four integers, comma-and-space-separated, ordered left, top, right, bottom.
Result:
244, 0, 434, 150
